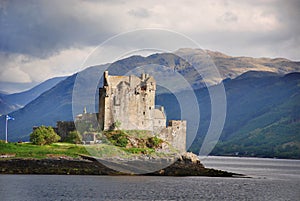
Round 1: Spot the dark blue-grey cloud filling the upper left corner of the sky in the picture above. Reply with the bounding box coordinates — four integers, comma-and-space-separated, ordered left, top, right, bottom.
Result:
0, 0, 113, 57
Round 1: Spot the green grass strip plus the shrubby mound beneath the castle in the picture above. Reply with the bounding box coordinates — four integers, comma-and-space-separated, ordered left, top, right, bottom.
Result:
0, 130, 175, 158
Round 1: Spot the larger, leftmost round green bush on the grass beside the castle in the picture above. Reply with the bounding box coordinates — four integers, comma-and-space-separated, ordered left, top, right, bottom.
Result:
30, 126, 60, 145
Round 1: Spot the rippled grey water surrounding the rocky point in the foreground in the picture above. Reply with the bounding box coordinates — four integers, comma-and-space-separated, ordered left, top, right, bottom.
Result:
0, 157, 300, 200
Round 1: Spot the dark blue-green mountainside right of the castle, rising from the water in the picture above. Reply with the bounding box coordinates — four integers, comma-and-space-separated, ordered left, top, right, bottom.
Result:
191, 72, 300, 159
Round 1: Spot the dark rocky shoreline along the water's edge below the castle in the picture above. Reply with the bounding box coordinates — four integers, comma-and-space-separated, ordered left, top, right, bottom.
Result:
0, 153, 242, 177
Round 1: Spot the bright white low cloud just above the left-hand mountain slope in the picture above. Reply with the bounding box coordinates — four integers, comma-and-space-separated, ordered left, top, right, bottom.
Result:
0, 47, 94, 83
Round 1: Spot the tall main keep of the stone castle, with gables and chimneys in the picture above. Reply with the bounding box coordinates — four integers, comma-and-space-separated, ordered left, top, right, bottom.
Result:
99, 72, 156, 131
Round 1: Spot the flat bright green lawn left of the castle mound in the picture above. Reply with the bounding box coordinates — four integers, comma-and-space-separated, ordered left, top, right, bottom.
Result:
0, 142, 89, 158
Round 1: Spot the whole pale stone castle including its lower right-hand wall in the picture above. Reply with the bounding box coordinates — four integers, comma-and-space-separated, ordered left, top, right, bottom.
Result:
98, 71, 186, 152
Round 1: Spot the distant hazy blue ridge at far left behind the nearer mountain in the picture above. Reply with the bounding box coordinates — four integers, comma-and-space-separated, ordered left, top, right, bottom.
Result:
0, 77, 66, 114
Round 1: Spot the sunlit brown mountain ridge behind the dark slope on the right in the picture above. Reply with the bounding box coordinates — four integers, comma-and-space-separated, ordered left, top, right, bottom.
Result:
174, 48, 300, 79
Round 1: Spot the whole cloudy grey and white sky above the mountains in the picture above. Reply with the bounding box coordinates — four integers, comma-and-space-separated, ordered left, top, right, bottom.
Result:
0, 0, 300, 92
